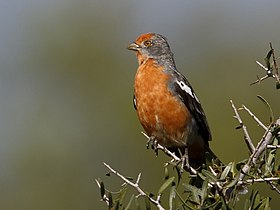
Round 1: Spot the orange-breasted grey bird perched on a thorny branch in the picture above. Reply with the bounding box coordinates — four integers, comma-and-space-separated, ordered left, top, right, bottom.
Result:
127, 33, 216, 169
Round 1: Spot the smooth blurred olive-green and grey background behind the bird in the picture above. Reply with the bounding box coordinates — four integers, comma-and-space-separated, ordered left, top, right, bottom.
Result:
0, 0, 280, 210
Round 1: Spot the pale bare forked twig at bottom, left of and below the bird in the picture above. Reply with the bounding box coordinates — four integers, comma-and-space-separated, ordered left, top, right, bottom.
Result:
103, 163, 164, 210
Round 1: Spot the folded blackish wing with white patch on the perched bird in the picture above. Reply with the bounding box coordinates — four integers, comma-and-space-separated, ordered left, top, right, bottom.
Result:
173, 71, 212, 145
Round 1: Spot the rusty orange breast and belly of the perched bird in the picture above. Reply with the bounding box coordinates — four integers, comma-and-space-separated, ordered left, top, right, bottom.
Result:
134, 59, 190, 147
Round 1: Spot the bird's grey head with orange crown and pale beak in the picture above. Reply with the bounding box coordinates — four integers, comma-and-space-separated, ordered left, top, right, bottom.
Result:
127, 33, 173, 64
